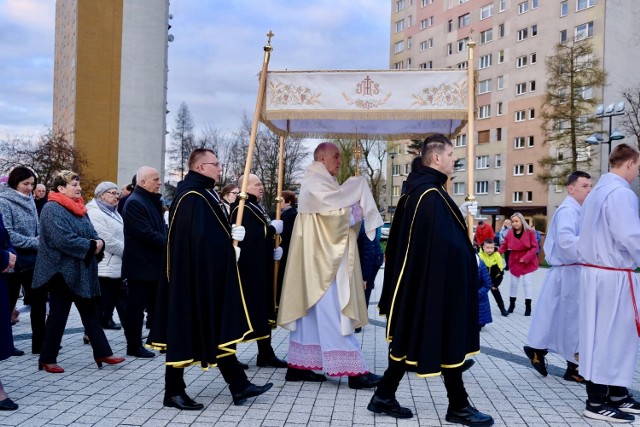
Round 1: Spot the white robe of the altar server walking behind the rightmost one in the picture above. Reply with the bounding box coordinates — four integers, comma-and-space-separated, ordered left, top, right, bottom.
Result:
528, 196, 582, 363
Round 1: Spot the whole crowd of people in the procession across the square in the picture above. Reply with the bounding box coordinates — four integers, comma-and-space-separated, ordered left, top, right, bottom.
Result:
0, 139, 640, 426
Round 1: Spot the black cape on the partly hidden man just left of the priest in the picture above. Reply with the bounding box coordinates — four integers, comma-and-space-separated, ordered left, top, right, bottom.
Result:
231, 194, 276, 341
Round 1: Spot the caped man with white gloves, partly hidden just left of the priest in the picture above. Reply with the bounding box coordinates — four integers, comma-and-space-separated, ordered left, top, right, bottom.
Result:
231, 174, 287, 368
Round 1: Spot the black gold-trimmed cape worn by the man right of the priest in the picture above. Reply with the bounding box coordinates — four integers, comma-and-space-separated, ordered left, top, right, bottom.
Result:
378, 166, 480, 376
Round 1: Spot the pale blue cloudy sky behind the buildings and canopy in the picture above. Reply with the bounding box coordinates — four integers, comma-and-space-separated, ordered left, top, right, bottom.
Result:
0, 0, 391, 138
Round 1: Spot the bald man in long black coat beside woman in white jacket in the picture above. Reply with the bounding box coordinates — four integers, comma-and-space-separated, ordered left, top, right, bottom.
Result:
122, 166, 167, 357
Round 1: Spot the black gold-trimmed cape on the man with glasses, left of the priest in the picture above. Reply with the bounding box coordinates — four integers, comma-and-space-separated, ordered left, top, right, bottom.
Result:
147, 171, 251, 368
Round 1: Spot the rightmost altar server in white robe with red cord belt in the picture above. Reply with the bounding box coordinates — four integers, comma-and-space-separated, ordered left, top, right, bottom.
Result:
578, 144, 640, 422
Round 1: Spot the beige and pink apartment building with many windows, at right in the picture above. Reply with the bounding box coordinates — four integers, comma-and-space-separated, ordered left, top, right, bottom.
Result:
388, 0, 640, 226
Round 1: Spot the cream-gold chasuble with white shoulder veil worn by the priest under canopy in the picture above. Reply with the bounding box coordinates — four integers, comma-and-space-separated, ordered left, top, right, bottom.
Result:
278, 162, 382, 335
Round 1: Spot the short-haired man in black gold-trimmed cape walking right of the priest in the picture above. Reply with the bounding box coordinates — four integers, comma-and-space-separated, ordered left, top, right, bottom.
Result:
368, 135, 493, 426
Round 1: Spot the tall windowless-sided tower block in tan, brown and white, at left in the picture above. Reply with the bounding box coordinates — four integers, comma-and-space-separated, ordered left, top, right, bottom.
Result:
53, 0, 169, 184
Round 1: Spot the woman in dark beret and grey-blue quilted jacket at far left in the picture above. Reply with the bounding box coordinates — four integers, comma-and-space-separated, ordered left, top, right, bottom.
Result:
0, 166, 46, 356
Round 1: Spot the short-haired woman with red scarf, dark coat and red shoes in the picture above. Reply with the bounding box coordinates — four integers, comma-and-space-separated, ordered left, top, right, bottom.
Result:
33, 171, 124, 373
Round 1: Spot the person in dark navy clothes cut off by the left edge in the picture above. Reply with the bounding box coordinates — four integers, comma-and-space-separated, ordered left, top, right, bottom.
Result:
0, 215, 18, 411
